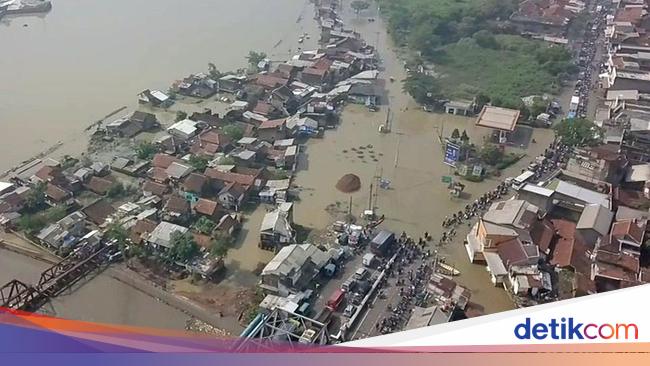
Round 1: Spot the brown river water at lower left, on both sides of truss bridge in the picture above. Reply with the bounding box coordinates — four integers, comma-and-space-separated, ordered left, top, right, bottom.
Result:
0, 249, 187, 330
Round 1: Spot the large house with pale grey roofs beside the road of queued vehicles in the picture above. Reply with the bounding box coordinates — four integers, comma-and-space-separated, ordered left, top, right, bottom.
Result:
259, 244, 330, 296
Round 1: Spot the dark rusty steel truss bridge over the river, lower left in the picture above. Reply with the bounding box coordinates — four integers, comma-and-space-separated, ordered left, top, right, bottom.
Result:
0, 245, 117, 312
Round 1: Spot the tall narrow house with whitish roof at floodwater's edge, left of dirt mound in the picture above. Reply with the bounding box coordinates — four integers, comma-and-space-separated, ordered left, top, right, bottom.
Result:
260, 204, 296, 250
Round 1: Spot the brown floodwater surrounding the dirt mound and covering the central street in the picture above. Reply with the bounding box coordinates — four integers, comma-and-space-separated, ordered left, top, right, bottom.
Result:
296, 5, 553, 313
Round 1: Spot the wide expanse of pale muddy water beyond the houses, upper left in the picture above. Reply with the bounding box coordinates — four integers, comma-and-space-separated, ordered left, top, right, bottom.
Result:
0, 0, 318, 171
